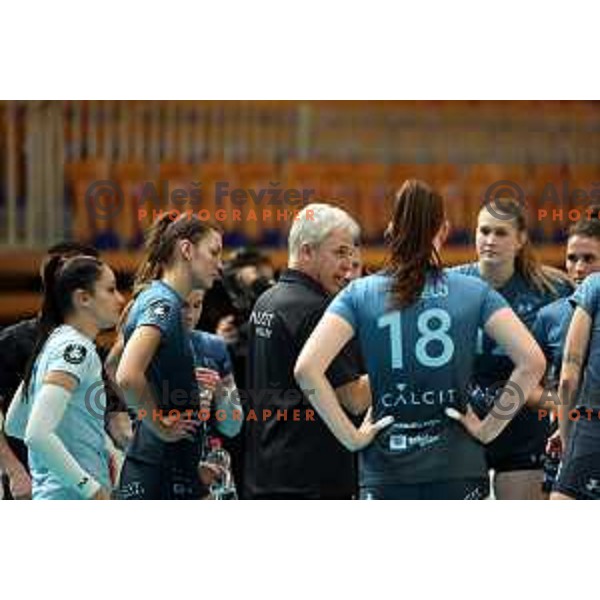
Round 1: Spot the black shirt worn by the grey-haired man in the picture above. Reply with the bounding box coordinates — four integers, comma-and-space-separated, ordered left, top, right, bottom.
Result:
242, 269, 362, 498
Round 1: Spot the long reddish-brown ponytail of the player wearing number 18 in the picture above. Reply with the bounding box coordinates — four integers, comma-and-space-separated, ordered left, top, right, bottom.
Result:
386, 180, 445, 308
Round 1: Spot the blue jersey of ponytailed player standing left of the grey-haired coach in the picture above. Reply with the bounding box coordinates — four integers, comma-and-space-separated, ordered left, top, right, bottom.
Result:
123, 281, 200, 465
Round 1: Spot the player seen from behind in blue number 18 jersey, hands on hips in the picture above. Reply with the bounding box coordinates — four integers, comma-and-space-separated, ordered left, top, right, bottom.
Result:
295, 181, 545, 499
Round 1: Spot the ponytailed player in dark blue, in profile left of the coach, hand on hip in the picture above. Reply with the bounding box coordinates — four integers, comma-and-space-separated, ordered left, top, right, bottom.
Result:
116, 213, 222, 499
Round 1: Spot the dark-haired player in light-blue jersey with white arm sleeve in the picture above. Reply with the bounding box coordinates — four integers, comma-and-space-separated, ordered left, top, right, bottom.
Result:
6, 256, 123, 500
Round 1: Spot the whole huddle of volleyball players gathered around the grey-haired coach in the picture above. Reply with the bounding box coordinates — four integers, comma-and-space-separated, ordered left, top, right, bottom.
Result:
0, 180, 600, 499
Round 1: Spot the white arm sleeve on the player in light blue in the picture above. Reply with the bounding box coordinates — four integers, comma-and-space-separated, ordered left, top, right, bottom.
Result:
25, 383, 100, 498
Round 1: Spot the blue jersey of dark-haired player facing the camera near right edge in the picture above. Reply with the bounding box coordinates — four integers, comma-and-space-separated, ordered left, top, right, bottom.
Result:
532, 298, 575, 387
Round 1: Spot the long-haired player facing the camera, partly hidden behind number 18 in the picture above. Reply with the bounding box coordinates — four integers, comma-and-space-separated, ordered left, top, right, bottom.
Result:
457, 198, 572, 499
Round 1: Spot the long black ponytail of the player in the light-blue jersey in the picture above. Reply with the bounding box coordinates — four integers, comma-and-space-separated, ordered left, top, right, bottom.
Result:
23, 256, 103, 398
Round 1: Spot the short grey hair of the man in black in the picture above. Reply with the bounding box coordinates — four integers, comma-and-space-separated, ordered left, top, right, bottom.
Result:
288, 203, 360, 260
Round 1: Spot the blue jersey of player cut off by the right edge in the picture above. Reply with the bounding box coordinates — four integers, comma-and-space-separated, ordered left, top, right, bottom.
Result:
571, 273, 600, 409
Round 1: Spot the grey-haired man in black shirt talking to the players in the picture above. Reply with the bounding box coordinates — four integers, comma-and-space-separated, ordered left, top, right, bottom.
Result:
243, 204, 370, 499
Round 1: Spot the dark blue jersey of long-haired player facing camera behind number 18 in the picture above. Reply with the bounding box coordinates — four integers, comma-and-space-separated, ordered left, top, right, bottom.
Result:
453, 263, 572, 415
